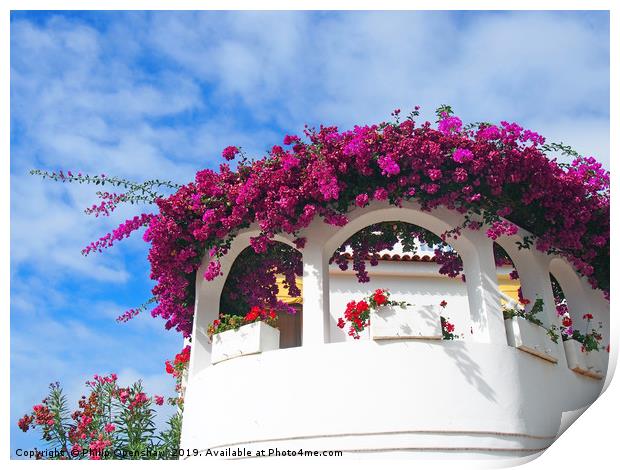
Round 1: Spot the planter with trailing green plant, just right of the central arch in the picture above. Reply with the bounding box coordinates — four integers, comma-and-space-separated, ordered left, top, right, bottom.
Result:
502, 299, 559, 363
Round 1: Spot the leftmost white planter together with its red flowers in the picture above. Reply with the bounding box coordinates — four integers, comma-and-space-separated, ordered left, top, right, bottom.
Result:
207, 306, 280, 364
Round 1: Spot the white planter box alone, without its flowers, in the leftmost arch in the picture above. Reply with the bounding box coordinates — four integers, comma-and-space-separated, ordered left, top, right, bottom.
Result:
211, 321, 280, 364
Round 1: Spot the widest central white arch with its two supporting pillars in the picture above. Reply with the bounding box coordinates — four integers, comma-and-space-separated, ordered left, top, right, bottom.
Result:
296, 201, 506, 344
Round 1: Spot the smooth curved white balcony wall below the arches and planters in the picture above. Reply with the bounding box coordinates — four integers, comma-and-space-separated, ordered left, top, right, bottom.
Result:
182, 340, 602, 458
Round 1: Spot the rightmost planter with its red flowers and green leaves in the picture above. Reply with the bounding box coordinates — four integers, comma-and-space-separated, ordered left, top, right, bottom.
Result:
562, 313, 604, 379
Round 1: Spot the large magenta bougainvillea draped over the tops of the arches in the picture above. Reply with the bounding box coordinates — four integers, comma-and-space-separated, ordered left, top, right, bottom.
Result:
34, 106, 610, 336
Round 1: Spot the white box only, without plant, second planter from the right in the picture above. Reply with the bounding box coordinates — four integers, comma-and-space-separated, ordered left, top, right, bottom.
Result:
504, 317, 558, 363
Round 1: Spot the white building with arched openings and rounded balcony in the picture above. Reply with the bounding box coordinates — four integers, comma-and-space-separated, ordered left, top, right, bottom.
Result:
181, 202, 609, 459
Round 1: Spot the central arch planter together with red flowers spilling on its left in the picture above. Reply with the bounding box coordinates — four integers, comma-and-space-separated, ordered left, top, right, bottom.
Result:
338, 289, 442, 340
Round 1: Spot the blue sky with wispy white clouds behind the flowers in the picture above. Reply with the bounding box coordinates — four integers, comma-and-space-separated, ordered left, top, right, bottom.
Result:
11, 12, 609, 456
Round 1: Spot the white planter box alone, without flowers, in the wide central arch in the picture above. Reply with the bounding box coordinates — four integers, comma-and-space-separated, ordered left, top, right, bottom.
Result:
370, 305, 443, 339
